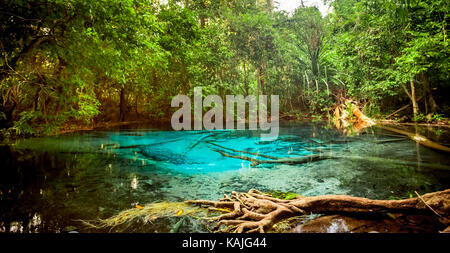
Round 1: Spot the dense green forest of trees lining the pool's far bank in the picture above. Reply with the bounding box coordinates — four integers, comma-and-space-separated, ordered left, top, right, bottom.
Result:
0, 0, 450, 135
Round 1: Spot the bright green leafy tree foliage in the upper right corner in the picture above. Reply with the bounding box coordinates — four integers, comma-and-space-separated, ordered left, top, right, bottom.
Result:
327, 0, 450, 117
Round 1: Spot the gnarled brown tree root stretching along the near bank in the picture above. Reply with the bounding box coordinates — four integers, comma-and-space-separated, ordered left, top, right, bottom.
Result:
186, 189, 450, 233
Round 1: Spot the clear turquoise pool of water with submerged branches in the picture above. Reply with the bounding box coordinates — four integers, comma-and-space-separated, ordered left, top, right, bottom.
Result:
0, 123, 450, 232
